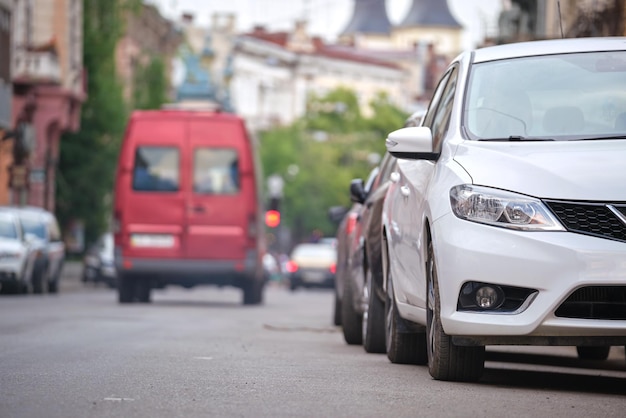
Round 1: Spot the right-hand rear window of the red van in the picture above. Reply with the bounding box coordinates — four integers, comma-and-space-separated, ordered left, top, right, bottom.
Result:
193, 147, 240, 194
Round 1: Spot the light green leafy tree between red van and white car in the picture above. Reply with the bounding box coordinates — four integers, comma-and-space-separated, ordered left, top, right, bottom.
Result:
260, 88, 408, 245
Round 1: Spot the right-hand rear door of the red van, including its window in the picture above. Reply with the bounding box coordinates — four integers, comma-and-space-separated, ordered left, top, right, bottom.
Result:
185, 116, 247, 260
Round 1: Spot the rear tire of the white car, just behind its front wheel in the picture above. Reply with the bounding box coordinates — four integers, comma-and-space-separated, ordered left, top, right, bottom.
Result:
385, 271, 428, 364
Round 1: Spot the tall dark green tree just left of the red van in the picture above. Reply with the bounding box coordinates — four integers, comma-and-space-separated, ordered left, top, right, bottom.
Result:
56, 0, 141, 248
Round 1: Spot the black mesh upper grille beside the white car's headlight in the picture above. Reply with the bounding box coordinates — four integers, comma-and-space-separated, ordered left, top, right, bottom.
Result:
544, 200, 626, 242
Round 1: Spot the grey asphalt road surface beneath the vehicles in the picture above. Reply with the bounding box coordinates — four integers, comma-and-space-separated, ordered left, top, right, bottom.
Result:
0, 264, 626, 418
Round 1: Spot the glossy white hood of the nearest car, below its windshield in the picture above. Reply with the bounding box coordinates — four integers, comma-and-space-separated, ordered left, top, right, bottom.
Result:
454, 140, 626, 201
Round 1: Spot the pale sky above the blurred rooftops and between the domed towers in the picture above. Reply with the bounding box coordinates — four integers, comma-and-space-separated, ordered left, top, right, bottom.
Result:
146, 0, 502, 49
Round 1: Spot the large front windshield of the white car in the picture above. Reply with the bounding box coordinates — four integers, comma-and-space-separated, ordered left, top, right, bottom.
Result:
463, 51, 626, 141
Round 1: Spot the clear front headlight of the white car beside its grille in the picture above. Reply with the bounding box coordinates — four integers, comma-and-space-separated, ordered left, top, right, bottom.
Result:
450, 184, 565, 231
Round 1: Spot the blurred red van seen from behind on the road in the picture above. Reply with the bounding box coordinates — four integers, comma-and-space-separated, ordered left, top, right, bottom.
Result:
114, 109, 265, 305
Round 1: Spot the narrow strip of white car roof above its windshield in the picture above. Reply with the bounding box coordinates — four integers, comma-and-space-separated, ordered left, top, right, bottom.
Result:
473, 36, 626, 63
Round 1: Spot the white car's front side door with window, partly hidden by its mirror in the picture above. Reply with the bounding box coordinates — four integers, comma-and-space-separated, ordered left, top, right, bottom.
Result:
392, 66, 458, 307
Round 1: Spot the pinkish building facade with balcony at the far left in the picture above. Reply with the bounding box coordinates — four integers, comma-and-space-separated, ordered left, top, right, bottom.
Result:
8, 0, 86, 210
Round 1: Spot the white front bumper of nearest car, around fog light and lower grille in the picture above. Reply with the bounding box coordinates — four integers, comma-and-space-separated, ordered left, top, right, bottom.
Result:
433, 215, 626, 344
